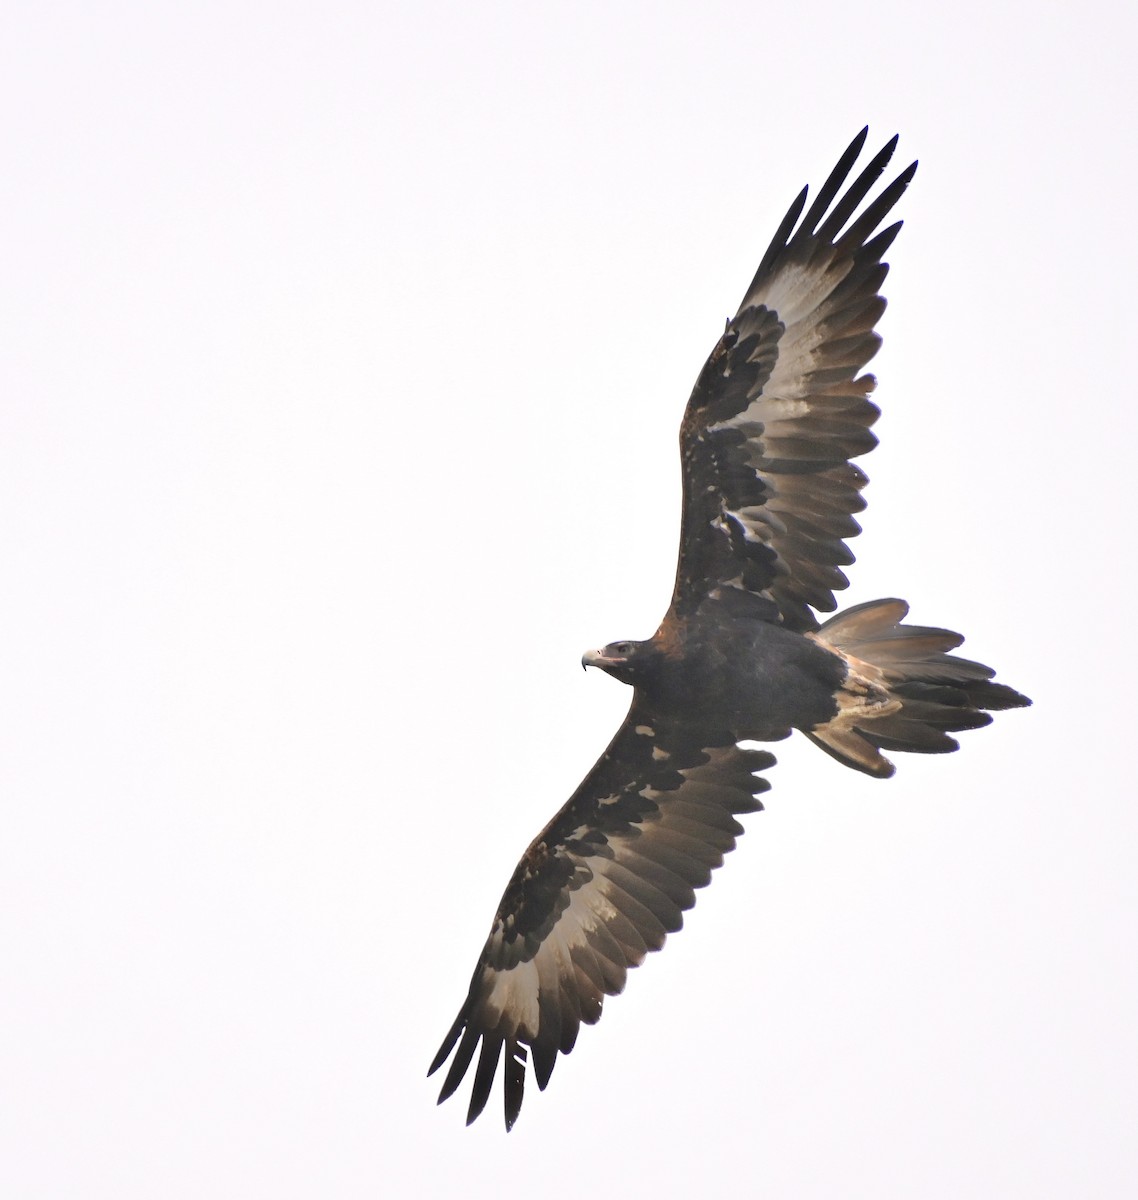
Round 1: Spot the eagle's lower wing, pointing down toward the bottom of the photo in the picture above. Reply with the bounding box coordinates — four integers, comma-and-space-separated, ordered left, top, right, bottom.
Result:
431, 701, 774, 1129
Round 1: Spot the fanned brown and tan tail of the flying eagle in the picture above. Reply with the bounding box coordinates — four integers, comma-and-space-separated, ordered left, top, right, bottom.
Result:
807, 600, 1031, 778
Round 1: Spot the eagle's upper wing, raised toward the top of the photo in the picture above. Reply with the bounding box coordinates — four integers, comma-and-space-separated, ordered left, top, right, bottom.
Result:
672, 130, 917, 630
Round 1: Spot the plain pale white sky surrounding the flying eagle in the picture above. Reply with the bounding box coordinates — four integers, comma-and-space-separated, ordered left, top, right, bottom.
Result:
0, 0, 1138, 1200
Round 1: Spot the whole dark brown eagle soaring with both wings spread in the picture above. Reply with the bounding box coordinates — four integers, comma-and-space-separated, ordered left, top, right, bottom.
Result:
431, 130, 1030, 1129
